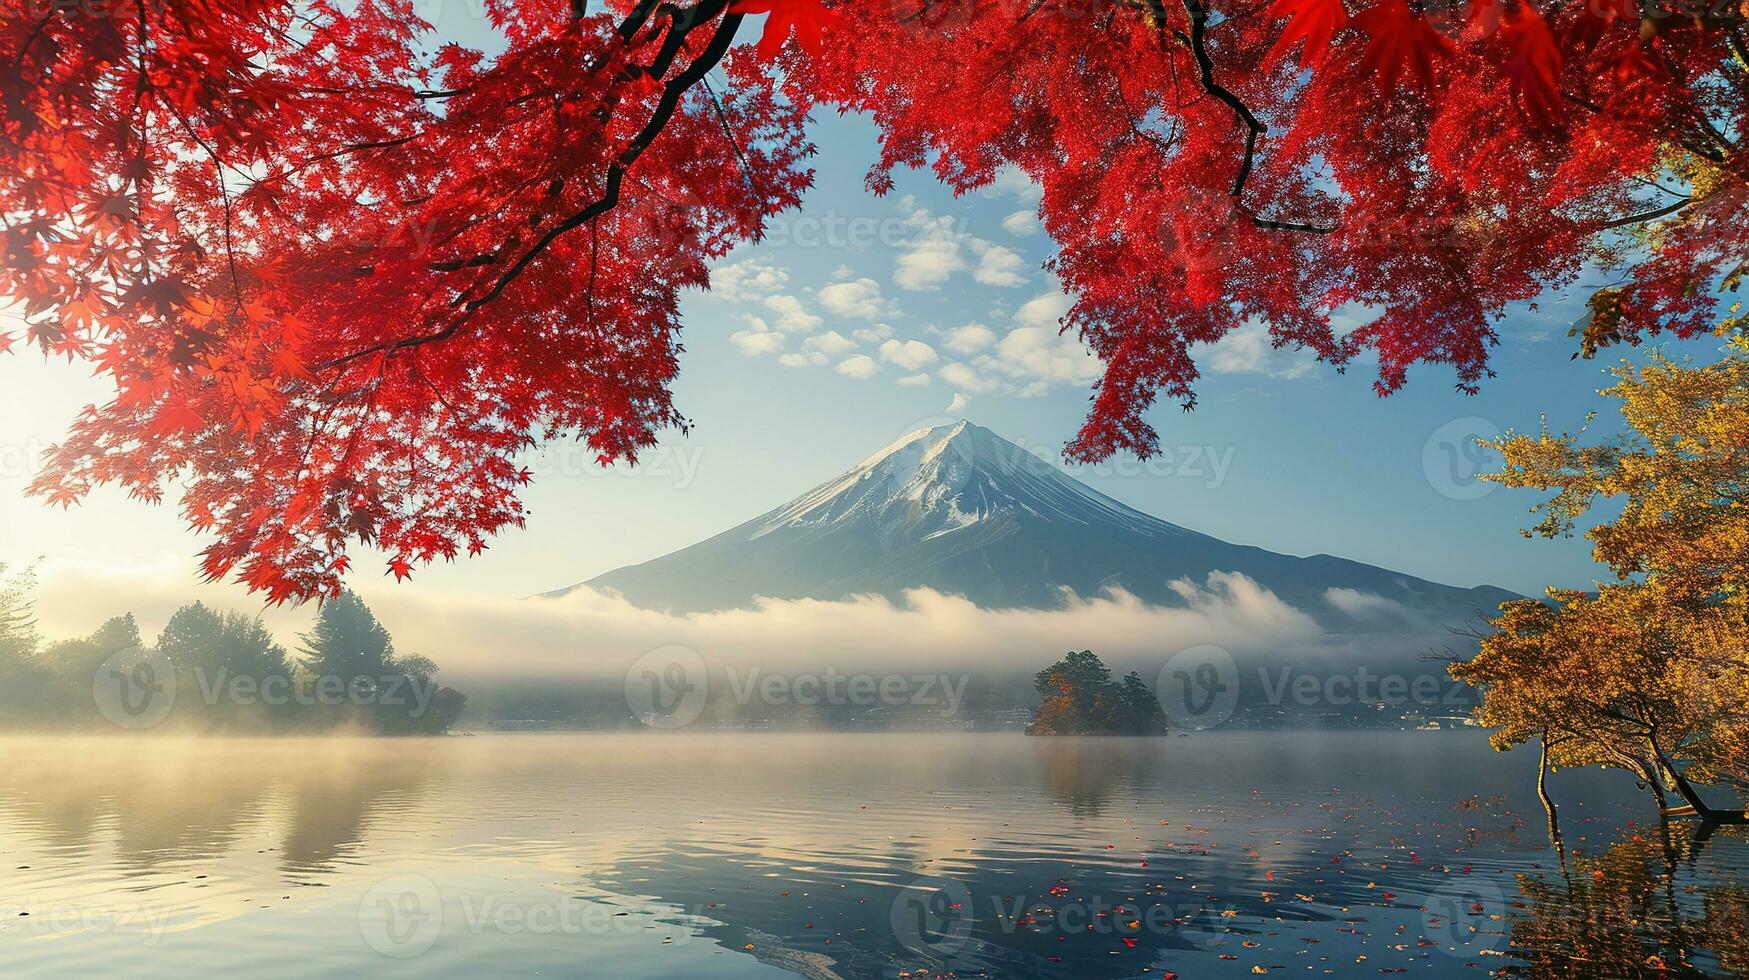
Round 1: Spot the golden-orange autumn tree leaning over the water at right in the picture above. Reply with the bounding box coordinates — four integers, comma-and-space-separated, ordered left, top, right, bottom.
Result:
1452, 334, 1749, 821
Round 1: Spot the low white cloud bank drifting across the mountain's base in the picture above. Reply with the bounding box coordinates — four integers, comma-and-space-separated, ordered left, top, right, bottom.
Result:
23, 565, 1450, 686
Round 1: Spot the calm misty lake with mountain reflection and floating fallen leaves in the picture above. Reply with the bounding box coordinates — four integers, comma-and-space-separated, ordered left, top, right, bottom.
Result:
0, 730, 1749, 980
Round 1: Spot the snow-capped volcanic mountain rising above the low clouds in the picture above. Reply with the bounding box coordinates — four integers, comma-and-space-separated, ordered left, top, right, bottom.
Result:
547, 420, 1515, 632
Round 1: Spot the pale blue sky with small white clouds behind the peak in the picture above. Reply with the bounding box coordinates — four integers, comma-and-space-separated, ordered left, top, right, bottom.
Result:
0, 11, 1714, 623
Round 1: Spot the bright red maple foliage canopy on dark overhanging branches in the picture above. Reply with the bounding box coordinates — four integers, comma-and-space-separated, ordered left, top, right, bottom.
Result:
0, 0, 1749, 600
